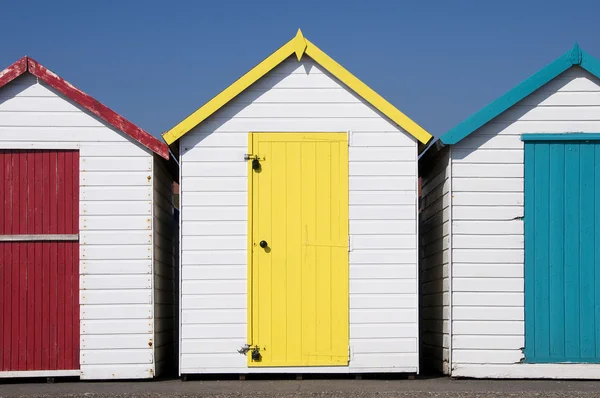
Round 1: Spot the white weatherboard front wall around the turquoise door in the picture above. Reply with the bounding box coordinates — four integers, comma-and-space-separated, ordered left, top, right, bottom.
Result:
452, 67, 600, 378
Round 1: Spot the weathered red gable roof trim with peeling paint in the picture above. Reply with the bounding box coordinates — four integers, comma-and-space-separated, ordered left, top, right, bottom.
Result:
0, 57, 169, 159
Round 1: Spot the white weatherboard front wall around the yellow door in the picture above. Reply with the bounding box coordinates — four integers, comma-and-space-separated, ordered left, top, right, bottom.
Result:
180, 56, 418, 374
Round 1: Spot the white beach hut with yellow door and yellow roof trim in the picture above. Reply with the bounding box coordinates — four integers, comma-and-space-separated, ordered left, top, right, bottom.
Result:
163, 31, 431, 375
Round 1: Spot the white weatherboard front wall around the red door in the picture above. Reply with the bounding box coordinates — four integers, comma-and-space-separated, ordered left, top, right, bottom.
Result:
0, 74, 173, 379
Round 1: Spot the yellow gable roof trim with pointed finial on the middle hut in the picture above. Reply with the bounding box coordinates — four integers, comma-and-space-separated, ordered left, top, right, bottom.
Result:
163, 29, 432, 145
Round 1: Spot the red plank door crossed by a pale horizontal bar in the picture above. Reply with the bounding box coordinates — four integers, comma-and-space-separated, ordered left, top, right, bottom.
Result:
0, 149, 79, 371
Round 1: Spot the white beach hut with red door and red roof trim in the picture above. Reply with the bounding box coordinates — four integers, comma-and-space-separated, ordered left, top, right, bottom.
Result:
0, 57, 177, 379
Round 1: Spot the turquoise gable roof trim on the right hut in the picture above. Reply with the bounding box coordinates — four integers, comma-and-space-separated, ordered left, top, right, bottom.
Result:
440, 43, 600, 145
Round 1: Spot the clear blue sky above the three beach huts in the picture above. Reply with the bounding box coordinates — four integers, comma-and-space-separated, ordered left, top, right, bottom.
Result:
0, 0, 600, 136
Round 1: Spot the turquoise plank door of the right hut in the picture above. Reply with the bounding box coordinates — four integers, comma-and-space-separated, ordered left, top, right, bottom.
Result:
523, 134, 600, 363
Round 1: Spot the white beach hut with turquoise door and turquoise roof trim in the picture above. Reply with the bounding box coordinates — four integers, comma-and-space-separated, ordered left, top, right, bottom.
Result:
420, 45, 600, 379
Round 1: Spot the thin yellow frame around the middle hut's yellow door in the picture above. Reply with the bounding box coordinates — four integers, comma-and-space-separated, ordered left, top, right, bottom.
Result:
244, 131, 350, 367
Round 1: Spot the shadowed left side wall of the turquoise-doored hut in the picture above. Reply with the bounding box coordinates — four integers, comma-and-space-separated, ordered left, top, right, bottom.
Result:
419, 148, 451, 373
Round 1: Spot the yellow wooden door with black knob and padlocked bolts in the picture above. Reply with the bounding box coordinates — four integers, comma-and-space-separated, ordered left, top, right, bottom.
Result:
248, 133, 349, 366
